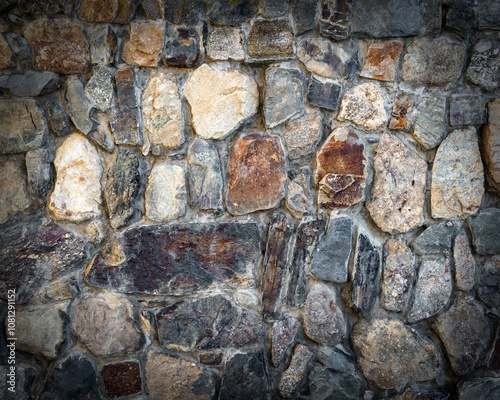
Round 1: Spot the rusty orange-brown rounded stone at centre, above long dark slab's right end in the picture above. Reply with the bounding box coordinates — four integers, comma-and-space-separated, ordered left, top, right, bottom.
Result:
226, 131, 287, 215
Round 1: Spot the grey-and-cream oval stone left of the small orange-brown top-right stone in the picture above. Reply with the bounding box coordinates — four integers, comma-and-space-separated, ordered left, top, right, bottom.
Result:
297, 38, 357, 80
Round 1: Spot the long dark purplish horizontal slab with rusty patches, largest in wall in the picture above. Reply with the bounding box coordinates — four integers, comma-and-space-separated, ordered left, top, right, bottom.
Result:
86, 222, 261, 295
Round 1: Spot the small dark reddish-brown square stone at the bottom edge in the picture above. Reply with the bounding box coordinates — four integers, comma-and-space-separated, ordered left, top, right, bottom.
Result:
101, 361, 142, 398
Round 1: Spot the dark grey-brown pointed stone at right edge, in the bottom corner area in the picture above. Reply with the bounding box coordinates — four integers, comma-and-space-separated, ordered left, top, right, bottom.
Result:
434, 297, 490, 376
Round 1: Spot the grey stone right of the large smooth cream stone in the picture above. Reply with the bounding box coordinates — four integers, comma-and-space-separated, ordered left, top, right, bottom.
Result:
264, 67, 306, 128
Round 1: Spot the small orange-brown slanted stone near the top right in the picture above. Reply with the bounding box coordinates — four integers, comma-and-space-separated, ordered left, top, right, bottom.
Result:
360, 41, 403, 81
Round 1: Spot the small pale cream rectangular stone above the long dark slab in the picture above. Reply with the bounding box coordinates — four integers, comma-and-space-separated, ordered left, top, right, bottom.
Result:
146, 163, 187, 222
